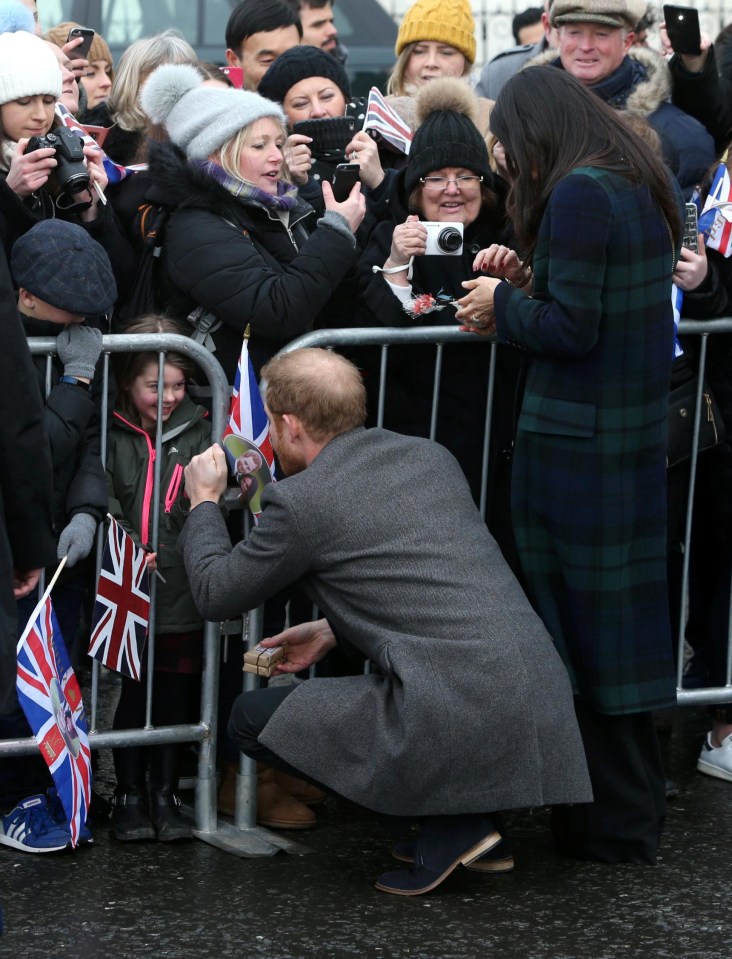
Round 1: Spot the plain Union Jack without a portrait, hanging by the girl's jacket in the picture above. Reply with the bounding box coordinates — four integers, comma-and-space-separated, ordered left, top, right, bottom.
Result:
89, 516, 150, 679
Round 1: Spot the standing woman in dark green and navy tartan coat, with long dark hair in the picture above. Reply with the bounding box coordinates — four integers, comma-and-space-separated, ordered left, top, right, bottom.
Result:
458, 67, 681, 863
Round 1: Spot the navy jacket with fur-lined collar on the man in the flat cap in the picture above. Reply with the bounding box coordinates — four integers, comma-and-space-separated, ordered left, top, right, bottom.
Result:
524, 47, 716, 199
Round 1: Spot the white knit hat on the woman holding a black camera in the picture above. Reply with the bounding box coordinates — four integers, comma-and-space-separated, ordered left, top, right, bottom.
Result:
0, 30, 61, 104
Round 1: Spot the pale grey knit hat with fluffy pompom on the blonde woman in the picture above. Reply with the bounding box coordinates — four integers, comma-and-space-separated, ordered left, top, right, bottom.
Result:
140, 63, 285, 160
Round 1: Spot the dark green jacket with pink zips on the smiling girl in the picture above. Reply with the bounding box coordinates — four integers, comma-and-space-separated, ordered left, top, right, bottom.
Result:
107, 397, 211, 633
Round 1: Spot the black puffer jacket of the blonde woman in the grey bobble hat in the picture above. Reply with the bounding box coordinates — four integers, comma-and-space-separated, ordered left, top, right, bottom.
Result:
144, 143, 356, 382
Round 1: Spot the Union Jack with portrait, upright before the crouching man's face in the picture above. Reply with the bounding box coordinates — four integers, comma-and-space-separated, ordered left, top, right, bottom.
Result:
222, 327, 275, 520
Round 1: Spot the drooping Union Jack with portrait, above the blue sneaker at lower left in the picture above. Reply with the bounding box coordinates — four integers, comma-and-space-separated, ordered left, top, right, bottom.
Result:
17, 595, 91, 846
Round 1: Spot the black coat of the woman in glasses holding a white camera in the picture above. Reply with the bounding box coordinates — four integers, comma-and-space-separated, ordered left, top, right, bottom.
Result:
354, 172, 520, 563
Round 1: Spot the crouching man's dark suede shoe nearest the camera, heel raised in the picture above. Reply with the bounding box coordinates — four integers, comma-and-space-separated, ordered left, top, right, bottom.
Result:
376, 814, 501, 896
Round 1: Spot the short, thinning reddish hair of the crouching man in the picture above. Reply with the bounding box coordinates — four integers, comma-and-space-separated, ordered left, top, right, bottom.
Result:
261, 349, 366, 442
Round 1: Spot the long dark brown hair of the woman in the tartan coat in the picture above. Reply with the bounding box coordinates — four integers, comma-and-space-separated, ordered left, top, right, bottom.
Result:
490, 66, 682, 260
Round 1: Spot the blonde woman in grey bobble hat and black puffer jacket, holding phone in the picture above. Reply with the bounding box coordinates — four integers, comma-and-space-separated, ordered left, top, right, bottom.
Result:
141, 59, 365, 381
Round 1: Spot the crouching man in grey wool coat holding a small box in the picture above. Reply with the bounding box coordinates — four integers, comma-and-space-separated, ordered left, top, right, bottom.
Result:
180, 350, 592, 895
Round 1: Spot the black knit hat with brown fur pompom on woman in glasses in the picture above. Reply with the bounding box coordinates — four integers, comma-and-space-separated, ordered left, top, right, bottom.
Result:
404, 77, 492, 193
